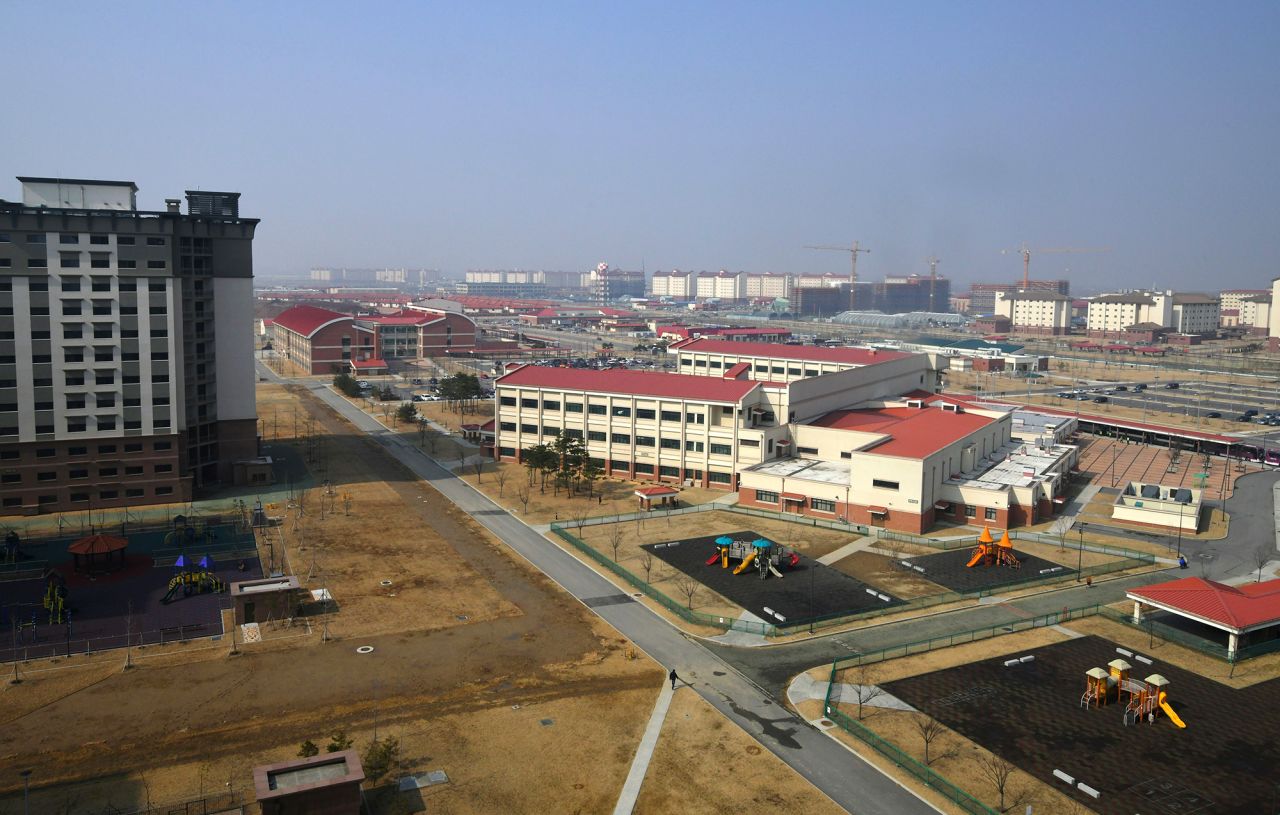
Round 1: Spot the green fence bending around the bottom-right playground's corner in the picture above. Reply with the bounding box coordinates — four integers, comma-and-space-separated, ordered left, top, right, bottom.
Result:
823, 605, 1101, 815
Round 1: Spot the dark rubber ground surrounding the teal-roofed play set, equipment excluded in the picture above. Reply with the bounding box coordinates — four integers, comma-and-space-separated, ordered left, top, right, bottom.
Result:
643, 530, 905, 623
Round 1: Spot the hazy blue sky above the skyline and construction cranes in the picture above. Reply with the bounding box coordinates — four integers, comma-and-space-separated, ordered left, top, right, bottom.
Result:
0, 0, 1280, 293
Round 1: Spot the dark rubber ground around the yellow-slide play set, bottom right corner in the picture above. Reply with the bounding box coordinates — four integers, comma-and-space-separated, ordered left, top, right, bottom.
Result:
884, 636, 1280, 815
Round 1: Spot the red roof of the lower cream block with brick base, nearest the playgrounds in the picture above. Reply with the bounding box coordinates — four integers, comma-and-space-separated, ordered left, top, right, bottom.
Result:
810, 407, 996, 458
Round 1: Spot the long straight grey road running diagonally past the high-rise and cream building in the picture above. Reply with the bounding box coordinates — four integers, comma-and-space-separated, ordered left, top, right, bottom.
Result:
267, 368, 937, 815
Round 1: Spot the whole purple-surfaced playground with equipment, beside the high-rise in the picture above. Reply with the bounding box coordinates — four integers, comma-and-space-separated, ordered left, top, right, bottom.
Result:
0, 518, 262, 661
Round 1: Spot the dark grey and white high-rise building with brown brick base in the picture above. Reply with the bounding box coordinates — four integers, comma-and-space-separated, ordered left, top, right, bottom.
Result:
0, 178, 257, 513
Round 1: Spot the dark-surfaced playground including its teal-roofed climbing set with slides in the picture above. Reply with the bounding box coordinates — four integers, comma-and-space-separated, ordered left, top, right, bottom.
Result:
643, 530, 904, 624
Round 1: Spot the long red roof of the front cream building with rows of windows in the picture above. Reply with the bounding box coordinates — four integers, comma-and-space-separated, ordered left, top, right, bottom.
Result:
497, 365, 760, 402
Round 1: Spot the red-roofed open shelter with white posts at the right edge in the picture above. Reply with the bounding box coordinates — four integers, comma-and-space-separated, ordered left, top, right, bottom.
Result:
1125, 577, 1280, 660
